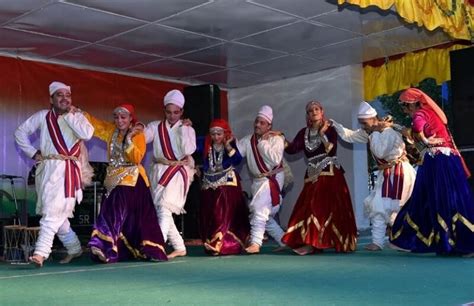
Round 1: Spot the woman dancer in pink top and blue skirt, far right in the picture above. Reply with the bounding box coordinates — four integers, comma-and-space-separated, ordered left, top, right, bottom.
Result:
391, 88, 474, 257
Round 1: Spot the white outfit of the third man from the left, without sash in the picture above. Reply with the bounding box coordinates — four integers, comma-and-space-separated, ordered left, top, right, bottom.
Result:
237, 135, 285, 245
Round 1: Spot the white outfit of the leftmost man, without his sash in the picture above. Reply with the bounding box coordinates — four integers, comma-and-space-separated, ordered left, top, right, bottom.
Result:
15, 110, 94, 258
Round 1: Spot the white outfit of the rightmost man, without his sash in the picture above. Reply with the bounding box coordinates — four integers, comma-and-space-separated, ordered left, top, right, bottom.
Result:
333, 121, 416, 247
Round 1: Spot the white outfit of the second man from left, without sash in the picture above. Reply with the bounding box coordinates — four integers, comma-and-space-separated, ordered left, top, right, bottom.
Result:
145, 121, 196, 251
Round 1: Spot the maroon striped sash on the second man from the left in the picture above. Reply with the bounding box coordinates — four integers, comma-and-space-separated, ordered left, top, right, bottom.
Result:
158, 121, 188, 194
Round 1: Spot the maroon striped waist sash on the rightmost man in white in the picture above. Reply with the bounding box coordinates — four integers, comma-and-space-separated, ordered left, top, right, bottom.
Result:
374, 156, 404, 200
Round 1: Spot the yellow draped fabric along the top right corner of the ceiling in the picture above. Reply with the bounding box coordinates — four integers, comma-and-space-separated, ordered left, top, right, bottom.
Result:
338, 0, 474, 41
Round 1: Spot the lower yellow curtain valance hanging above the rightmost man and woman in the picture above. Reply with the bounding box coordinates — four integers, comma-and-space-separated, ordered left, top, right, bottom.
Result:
364, 44, 468, 101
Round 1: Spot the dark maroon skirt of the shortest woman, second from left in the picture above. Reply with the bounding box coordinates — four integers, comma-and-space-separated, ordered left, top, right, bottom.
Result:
199, 180, 250, 255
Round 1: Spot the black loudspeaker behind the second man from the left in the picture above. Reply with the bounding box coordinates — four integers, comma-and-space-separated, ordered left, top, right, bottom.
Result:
183, 84, 221, 136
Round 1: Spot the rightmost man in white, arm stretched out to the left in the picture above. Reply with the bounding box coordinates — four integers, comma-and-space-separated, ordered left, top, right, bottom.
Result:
331, 102, 416, 251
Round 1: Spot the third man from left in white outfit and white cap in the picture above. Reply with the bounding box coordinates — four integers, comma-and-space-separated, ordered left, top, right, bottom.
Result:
237, 105, 285, 254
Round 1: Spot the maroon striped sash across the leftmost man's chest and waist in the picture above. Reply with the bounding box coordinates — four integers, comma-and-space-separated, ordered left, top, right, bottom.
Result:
46, 110, 81, 198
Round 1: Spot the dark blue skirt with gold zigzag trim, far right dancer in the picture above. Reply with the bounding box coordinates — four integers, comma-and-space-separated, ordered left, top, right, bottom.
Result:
391, 153, 474, 255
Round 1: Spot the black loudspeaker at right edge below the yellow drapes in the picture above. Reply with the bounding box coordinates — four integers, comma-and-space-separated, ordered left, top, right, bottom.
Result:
450, 47, 474, 149
